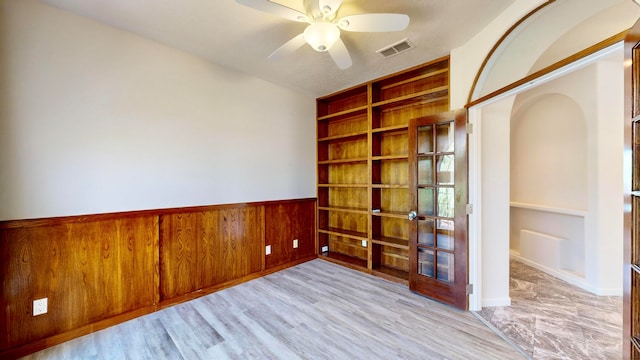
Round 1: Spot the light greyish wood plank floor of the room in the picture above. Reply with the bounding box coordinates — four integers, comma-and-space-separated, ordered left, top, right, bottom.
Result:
28, 260, 525, 360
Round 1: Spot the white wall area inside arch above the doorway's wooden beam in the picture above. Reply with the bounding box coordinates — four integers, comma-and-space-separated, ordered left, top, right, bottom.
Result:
473, 0, 640, 99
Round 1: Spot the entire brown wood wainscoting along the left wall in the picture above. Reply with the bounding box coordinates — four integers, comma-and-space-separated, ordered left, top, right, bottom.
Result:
0, 198, 317, 359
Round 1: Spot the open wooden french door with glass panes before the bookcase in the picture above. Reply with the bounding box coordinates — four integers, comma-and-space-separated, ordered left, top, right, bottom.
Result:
409, 109, 468, 310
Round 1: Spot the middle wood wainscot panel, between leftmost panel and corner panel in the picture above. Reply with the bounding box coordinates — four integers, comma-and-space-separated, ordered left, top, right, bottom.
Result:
160, 206, 264, 300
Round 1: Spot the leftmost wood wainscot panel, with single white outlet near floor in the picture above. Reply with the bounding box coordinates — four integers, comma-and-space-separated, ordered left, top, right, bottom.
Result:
0, 216, 158, 350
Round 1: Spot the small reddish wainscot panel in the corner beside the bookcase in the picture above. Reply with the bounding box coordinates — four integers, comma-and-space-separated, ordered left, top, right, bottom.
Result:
264, 201, 316, 269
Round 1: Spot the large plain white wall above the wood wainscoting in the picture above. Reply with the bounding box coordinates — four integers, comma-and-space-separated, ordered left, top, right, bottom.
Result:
0, 0, 315, 220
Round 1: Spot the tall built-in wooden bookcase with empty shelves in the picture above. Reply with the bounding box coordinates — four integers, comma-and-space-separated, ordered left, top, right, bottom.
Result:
317, 56, 449, 283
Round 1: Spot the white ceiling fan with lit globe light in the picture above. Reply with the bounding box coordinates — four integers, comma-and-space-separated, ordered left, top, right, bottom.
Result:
236, 0, 409, 70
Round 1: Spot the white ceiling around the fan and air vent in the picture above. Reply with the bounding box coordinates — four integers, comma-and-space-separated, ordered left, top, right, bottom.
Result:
41, 0, 514, 96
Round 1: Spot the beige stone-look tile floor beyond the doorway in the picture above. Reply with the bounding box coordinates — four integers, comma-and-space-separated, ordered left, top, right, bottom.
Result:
476, 260, 622, 360
